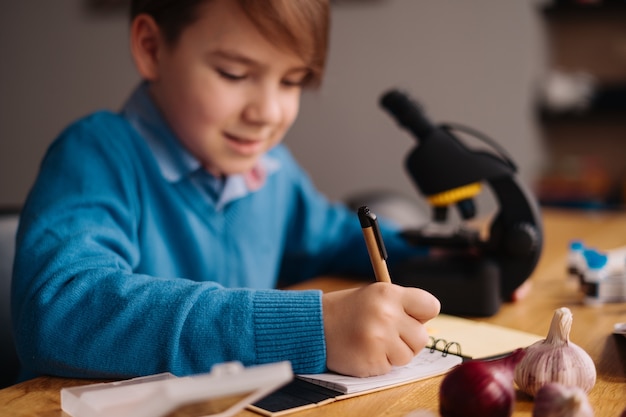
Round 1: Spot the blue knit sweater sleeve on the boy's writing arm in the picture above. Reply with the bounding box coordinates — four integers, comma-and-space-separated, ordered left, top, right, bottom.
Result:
12, 113, 326, 378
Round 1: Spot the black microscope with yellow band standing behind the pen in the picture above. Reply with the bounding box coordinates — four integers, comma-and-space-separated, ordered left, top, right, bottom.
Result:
380, 90, 543, 316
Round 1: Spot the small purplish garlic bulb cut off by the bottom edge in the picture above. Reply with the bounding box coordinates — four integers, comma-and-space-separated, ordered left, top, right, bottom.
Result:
533, 382, 593, 417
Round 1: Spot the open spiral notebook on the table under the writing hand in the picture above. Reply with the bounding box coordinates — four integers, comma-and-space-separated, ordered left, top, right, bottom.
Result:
248, 314, 543, 417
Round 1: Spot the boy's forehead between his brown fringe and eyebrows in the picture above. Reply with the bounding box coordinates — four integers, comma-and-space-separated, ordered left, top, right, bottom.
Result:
179, 0, 305, 67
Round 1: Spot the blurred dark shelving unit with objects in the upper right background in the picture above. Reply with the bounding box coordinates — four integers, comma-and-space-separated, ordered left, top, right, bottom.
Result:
535, 0, 626, 209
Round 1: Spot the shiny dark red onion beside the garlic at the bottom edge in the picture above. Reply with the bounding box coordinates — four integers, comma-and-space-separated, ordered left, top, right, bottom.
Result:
439, 349, 526, 417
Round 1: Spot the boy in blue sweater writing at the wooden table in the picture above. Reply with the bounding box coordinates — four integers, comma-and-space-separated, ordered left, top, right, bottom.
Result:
12, 0, 440, 378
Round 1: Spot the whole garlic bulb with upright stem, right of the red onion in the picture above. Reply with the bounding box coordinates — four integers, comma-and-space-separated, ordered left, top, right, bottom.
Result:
515, 307, 596, 396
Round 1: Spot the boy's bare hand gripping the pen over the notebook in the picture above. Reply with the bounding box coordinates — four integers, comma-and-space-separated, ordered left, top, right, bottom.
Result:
322, 282, 441, 377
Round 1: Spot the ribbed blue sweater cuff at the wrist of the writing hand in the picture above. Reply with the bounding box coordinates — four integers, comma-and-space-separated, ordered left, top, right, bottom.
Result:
254, 290, 326, 373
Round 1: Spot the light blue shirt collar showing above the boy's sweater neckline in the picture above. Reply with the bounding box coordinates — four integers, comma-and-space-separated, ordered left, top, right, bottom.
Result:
122, 82, 280, 206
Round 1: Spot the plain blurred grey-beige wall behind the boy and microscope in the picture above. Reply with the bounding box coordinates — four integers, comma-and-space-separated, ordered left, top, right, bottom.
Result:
0, 0, 546, 214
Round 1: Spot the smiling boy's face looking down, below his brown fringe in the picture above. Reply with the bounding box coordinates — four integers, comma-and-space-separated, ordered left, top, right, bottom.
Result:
144, 0, 308, 176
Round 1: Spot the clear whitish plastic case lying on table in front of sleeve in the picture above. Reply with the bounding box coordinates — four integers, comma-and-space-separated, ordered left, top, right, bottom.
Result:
61, 361, 293, 417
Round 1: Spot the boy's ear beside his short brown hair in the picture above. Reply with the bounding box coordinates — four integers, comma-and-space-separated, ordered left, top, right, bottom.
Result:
130, 14, 165, 81
